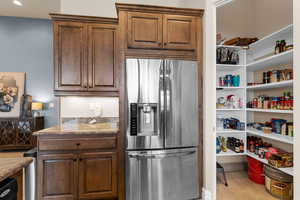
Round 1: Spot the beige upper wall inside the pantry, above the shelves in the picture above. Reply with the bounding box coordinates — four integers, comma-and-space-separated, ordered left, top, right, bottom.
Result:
217, 0, 293, 39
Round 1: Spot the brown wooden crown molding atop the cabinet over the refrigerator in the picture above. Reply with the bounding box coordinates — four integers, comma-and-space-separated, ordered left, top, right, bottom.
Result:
115, 3, 204, 17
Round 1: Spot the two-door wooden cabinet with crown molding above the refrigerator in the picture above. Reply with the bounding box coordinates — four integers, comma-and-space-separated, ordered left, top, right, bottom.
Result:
116, 3, 204, 52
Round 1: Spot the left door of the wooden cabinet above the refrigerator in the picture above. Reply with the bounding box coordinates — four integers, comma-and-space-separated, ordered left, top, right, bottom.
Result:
128, 12, 163, 48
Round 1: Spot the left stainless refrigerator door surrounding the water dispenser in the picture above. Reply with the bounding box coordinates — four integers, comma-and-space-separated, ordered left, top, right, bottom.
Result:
126, 59, 164, 149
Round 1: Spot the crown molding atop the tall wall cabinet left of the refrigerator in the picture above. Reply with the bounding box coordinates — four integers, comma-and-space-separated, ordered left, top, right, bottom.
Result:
49, 13, 118, 24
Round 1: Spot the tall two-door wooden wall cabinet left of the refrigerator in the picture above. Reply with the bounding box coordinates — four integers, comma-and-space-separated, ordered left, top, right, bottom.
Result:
51, 14, 118, 96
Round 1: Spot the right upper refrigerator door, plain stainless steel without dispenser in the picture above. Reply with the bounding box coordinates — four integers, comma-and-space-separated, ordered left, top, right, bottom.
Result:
165, 60, 199, 148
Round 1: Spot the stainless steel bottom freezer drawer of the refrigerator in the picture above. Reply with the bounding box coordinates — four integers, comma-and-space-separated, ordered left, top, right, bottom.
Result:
126, 148, 200, 200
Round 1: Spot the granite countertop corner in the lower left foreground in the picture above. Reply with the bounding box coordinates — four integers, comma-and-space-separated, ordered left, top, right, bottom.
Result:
0, 157, 33, 182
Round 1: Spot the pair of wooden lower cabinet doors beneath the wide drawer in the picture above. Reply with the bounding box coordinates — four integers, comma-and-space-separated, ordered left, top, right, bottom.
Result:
38, 151, 118, 200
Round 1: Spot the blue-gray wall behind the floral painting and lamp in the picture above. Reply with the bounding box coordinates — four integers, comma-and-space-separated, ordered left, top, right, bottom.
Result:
0, 16, 58, 127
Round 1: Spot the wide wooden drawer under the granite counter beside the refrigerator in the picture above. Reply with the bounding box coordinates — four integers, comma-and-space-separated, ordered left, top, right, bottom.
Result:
38, 137, 117, 151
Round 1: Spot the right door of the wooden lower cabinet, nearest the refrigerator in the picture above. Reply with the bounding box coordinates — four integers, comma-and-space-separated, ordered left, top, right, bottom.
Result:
79, 152, 117, 199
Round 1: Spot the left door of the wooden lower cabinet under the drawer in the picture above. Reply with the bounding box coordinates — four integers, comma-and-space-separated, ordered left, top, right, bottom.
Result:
38, 154, 77, 200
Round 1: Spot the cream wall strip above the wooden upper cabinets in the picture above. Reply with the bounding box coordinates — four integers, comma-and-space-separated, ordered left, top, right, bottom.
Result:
61, 0, 182, 17
